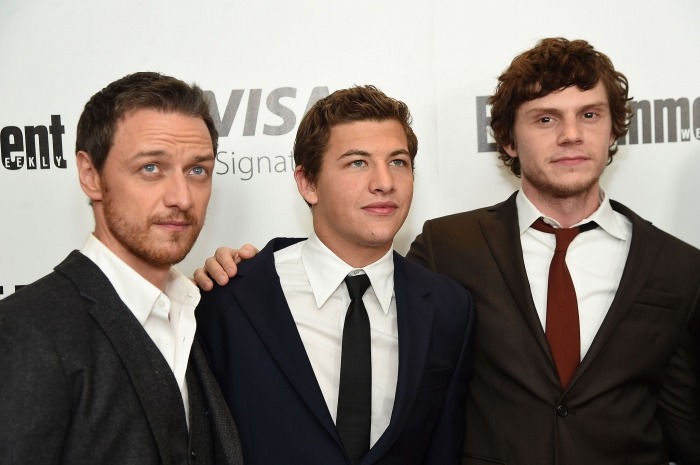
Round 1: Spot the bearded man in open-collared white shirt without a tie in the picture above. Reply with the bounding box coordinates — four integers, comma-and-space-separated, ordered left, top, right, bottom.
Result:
0, 72, 242, 465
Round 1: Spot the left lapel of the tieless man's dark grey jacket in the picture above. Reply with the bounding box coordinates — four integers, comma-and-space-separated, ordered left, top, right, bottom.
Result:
56, 251, 188, 463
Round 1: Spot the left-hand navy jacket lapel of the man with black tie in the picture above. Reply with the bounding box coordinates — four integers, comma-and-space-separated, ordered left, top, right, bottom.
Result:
232, 240, 340, 444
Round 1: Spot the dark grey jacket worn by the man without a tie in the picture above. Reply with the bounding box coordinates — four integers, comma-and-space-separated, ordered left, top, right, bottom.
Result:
0, 251, 242, 465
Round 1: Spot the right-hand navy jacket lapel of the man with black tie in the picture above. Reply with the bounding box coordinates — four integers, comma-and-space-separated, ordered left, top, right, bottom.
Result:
363, 252, 435, 463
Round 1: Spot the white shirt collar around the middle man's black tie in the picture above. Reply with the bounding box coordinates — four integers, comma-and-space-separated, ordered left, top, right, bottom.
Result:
301, 234, 394, 314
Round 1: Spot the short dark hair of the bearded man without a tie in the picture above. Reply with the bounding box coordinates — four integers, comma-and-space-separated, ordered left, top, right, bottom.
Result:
75, 72, 219, 172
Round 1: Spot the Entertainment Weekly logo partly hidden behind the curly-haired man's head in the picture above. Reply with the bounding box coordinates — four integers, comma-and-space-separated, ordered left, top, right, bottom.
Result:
476, 96, 700, 152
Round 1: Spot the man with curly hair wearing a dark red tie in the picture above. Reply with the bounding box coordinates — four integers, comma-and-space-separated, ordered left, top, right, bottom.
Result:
408, 38, 700, 465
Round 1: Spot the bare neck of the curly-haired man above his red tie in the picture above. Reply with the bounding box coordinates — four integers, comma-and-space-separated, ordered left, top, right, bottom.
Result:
522, 183, 600, 228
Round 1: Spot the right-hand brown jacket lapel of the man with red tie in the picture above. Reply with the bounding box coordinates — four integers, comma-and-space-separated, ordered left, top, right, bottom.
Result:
571, 200, 663, 378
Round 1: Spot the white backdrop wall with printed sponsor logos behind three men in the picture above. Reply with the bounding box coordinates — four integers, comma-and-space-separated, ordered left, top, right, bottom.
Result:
0, 0, 700, 298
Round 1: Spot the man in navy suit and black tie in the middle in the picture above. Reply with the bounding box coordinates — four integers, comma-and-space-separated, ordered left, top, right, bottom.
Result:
197, 86, 474, 465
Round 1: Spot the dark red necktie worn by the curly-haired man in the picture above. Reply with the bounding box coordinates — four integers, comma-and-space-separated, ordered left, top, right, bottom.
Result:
532, 218, 597, 389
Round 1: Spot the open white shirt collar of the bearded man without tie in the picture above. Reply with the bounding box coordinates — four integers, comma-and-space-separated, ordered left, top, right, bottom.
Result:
80, 234, 200, 325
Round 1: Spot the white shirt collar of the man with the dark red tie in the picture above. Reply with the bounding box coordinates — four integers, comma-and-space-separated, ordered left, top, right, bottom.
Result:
515, 188, 629, 240
